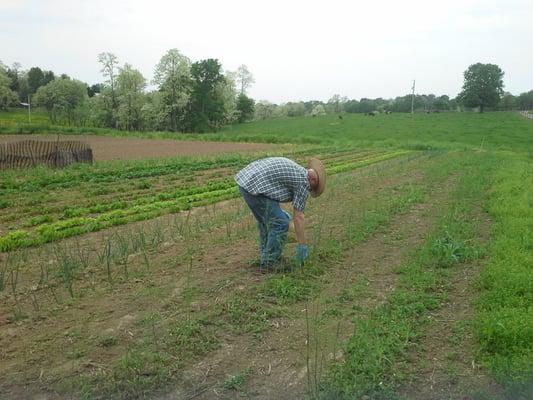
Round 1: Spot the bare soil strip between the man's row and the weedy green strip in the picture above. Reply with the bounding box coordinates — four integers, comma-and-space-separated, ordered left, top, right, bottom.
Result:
161, 176, 453, 400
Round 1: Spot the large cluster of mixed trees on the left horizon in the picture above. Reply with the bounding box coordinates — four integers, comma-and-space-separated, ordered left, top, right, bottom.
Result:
0, 49, 255, 132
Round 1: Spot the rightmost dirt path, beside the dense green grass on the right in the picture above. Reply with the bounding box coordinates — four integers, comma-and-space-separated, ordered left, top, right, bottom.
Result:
400, 210, 504, 400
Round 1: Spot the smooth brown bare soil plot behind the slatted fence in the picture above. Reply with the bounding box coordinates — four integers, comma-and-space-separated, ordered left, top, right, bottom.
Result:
0, 135, 274, 161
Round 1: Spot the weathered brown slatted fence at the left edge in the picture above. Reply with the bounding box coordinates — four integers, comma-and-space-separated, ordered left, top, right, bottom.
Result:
0, 140, 93, 169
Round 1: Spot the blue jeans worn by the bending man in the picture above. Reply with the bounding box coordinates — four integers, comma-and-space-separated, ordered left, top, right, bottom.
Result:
239, 186, 290, 266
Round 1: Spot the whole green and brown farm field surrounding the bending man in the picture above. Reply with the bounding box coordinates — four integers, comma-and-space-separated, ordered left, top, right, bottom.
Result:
0, 113, 533, 399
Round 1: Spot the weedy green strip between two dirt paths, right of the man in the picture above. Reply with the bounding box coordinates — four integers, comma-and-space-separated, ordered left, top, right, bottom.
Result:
322, 154, 493, 399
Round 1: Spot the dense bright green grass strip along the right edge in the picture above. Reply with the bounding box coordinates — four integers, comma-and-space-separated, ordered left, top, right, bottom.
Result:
475, 156, 533, 398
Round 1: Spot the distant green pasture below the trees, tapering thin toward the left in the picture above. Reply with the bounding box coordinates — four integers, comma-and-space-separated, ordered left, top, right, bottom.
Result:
4, 112, 533, 152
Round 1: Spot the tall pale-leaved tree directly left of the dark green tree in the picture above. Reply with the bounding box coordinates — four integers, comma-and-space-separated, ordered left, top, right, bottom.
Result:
153, 49, 191, 131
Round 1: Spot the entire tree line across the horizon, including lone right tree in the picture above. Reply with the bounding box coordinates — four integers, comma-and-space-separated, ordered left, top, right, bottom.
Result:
0, 58, 533, 132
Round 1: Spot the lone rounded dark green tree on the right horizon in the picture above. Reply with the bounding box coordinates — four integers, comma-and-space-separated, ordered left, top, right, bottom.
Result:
459, 63, 504, 113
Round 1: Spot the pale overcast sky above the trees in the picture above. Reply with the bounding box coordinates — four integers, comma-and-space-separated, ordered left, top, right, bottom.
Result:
0, 0, 533, 103
